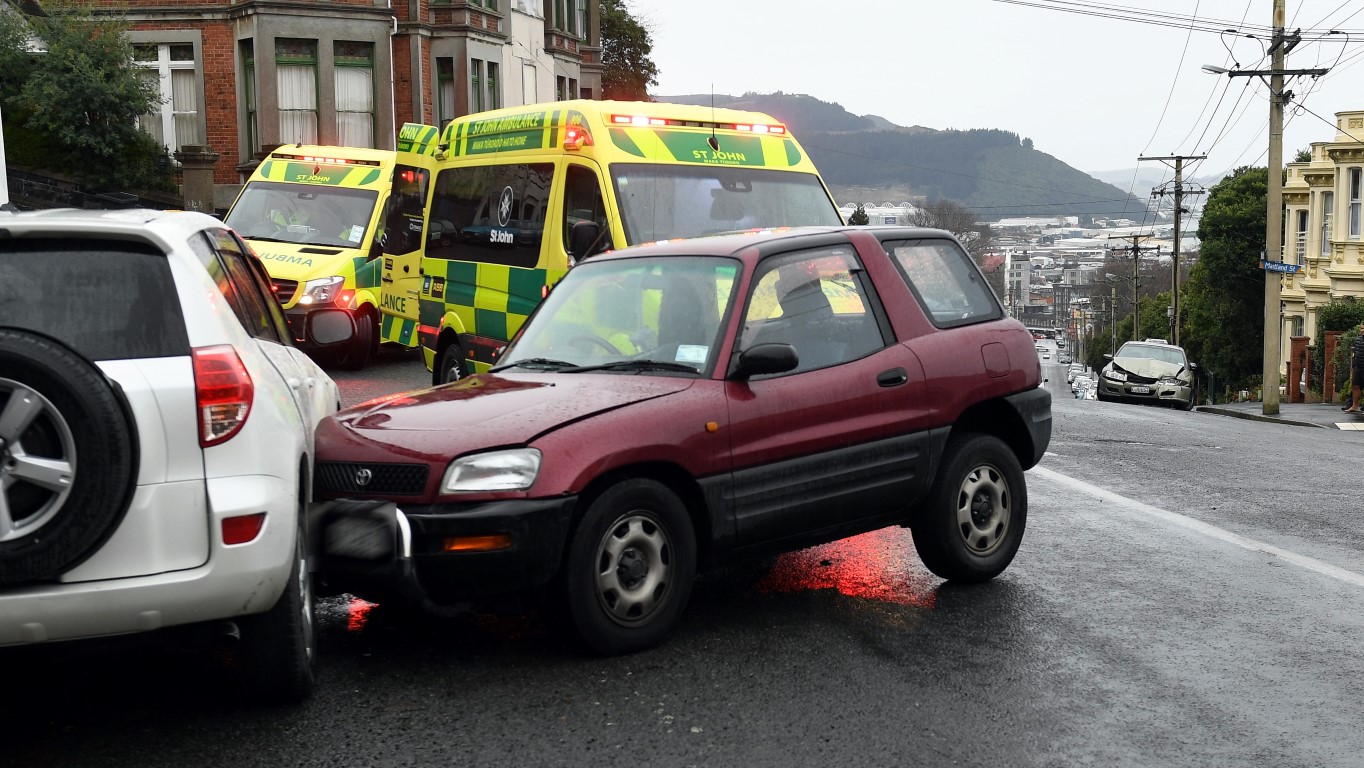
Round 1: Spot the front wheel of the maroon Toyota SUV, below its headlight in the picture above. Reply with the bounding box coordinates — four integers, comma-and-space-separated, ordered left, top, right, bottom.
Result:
563, 479, 696, 656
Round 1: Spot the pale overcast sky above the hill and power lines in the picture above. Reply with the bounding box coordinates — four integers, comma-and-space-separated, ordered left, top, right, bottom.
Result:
629, 0, 1364, 186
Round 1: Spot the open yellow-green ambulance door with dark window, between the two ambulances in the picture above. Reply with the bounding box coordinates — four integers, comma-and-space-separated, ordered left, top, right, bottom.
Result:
379, 164, 431, 346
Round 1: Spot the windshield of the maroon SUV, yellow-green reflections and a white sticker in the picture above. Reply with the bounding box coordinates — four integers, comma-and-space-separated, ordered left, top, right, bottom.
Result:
496, 256, 739, 374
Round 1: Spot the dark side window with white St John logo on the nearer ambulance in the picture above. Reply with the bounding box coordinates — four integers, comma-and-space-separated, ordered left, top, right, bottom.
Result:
427, 162, 554, 267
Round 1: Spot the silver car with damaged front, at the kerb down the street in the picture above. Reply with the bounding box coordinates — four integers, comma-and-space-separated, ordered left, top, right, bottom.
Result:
1097, 340, 1198, 411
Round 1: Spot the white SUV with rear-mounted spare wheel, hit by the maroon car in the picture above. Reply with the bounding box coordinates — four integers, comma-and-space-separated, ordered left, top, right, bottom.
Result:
0, 210, 355, 700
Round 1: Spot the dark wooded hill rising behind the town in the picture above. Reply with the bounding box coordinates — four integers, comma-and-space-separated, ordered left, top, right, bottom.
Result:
656, 91, 1146, 220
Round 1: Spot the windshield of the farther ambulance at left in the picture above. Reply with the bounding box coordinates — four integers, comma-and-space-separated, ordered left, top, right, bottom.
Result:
224, 181, 379, 248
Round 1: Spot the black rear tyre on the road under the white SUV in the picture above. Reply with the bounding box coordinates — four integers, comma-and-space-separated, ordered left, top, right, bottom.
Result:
237, 510, 316, 703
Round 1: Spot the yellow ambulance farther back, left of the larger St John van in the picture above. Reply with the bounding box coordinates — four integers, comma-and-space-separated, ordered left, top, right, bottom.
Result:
224, 125, 436, 370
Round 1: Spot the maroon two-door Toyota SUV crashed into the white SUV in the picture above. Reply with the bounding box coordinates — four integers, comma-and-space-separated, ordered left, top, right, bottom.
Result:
314, 228, 1052, 653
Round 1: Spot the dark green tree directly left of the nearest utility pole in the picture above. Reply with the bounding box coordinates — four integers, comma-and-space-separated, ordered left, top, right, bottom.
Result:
1180, 168, 1269, 389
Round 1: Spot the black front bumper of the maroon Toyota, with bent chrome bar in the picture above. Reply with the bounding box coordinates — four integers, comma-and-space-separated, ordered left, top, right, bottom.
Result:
310, 497, 577, 603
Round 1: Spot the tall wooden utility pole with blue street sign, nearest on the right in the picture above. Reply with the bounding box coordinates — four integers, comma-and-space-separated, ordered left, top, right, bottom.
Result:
1203, 0, 1330, 416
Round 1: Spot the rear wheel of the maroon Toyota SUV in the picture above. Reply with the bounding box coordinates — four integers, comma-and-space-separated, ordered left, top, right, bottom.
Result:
913, 434, 1027, 582
